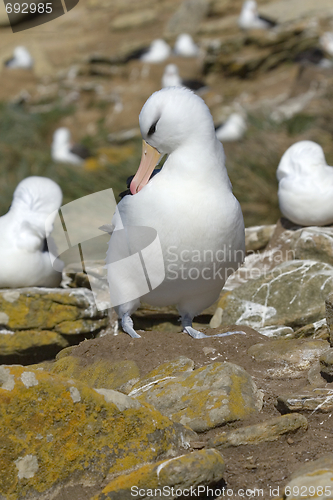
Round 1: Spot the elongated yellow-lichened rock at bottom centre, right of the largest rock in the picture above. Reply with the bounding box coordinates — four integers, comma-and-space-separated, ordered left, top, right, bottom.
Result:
94, 450, 225, 500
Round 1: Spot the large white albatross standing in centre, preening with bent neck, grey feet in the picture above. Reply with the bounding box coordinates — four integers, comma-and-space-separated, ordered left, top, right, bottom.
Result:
107, 87, 245, 338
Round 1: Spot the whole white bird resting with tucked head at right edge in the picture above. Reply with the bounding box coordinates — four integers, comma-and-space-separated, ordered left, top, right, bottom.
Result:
276, 141, 333, 226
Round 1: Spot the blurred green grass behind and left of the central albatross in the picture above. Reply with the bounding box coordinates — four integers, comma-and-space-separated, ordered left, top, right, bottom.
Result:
0, 104, 141, 215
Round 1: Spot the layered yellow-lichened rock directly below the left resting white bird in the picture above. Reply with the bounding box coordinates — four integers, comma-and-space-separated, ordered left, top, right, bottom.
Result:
0, 287, 108, 363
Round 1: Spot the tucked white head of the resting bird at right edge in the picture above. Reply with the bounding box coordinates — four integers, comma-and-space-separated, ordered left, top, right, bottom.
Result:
276, 141, 326, 181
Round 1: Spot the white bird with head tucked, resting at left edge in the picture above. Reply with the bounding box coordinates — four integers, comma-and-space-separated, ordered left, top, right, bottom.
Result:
0, 176, 62, 288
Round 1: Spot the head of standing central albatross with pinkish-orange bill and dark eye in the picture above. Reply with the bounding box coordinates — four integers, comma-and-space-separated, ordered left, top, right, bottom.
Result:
130, 87, 216, 194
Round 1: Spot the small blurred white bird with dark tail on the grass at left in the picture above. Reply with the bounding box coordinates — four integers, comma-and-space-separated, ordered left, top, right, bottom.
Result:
51, 127, 90, 165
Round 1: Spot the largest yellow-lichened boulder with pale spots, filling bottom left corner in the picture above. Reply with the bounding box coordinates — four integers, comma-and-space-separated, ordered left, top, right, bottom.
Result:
0, 366, 196, 500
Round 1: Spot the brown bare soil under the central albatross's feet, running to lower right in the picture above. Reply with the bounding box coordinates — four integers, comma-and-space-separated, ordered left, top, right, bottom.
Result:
66, 325, 333, 499
